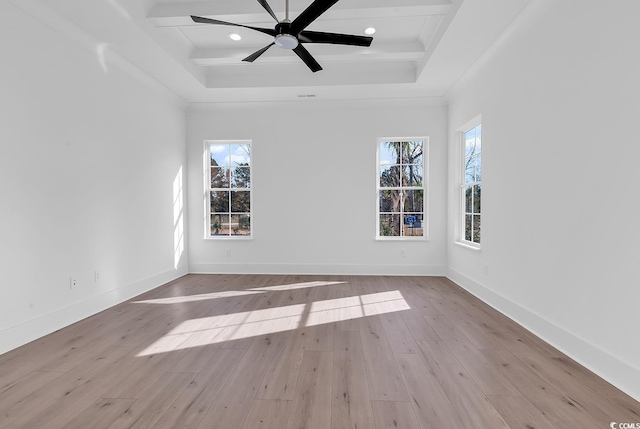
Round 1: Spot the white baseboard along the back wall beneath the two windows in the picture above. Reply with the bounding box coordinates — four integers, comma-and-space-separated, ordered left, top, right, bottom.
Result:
189, 263, 447, 276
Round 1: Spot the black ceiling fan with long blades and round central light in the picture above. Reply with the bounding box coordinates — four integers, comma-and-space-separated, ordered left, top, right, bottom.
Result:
191, 0, 373, 73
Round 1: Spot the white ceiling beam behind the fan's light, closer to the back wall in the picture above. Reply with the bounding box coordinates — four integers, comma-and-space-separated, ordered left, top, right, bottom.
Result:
190, 42, 424, 66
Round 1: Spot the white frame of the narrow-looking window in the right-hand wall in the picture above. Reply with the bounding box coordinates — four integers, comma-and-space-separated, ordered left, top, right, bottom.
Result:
456, 116, 484, 250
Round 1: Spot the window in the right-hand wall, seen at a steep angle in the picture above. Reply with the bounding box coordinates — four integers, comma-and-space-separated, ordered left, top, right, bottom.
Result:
460, 124, 482, 247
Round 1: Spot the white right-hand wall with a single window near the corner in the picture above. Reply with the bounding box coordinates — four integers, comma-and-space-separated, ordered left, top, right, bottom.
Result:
448, 0, 640, 398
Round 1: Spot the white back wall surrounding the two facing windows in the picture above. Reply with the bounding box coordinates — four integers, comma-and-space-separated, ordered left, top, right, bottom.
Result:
188, 101, 447, 274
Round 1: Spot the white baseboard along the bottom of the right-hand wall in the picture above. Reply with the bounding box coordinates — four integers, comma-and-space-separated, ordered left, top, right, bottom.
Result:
447, 269, 640, 401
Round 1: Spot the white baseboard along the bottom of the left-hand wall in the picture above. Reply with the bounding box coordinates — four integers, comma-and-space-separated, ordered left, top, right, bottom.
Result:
0, 266, 188, 354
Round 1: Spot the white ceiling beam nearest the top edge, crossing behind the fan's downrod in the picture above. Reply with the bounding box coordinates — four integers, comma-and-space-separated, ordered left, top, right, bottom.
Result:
147, 0, 451, 27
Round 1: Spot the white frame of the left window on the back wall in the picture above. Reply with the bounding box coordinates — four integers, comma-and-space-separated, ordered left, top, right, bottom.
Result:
203, 139, 255, 240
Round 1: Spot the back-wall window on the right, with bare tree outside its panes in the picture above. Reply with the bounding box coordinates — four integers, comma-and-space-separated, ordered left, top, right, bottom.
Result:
376, 138, 428, 239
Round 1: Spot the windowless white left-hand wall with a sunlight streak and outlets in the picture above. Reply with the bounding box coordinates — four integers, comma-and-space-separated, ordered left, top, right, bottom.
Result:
0, 1, 187, 353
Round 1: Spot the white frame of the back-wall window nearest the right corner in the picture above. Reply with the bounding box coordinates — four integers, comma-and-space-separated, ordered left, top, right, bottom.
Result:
375, 136, 430, 241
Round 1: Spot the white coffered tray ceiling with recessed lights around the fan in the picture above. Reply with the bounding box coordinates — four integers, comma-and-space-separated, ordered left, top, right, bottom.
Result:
17, 0, 530, 102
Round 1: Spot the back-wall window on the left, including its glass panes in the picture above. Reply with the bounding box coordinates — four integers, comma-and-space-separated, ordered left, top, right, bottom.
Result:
205, 141, 252, 238
